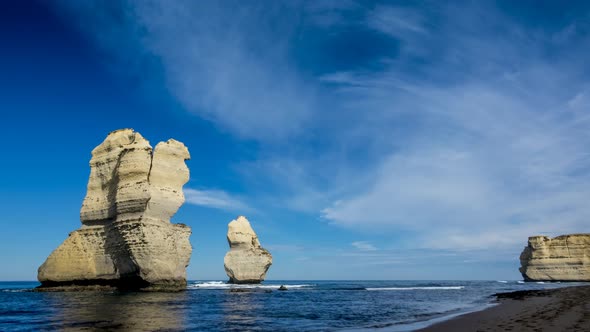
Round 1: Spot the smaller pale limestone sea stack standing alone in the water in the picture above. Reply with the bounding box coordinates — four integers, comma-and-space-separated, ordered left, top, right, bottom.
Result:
223, 216, 272, 284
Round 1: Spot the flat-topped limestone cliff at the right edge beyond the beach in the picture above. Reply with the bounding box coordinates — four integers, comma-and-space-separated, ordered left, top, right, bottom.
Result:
520, 234, 590, 281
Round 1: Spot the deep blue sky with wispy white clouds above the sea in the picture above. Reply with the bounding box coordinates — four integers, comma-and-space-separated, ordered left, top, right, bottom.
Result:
0, 1, 590, 280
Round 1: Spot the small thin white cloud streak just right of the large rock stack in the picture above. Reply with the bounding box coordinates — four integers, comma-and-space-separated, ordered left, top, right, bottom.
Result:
184, 188, 252, 211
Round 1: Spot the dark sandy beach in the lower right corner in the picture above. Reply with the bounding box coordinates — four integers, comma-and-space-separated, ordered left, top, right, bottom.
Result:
419, 286, 590, 332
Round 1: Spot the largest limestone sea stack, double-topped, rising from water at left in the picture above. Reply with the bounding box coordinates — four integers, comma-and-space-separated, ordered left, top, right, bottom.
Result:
38, 129, 192, 290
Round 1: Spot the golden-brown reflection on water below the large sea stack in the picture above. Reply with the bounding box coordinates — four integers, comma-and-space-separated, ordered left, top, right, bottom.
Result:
47, 292, 188, 331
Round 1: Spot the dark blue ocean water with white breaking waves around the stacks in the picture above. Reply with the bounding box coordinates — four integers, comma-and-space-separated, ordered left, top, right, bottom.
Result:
0, 280, 577, 332
